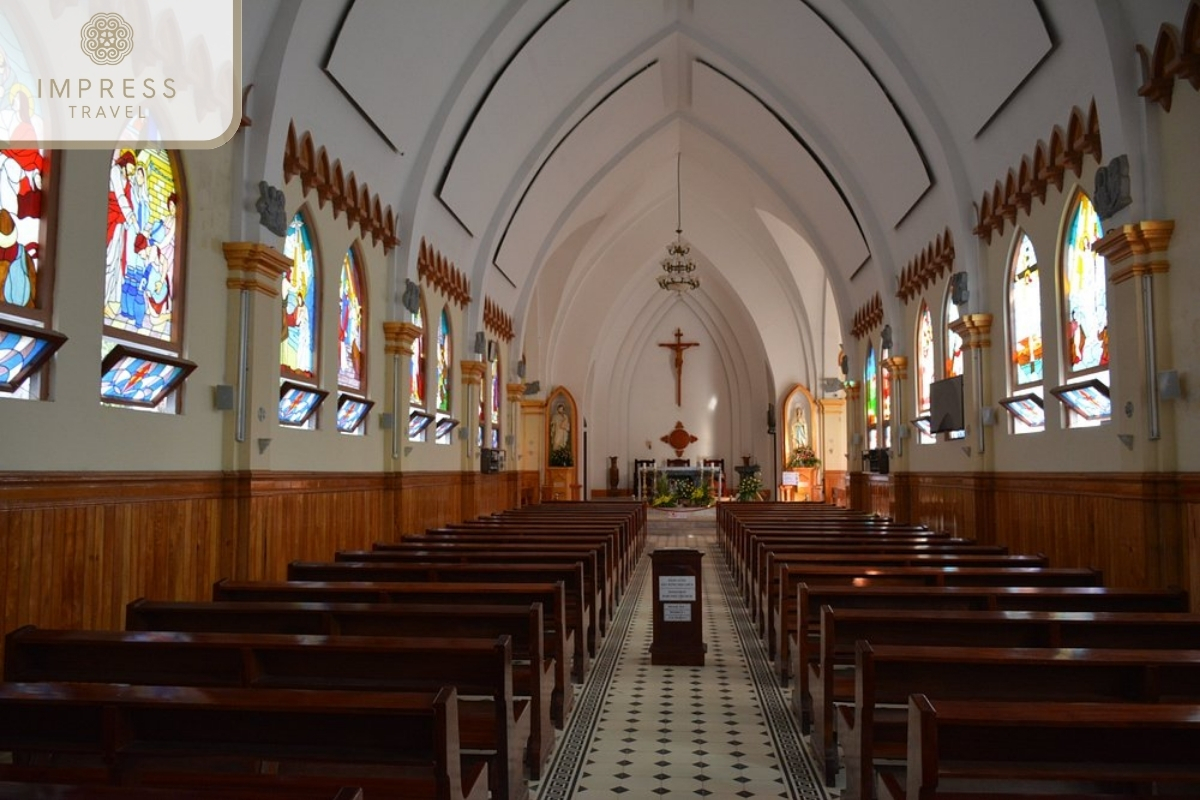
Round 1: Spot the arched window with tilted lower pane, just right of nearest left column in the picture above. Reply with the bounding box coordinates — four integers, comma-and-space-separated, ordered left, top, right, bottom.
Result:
280, 210, 329, 428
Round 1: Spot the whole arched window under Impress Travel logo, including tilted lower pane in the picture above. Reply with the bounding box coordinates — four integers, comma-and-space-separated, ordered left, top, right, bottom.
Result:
100, 148, 196, 413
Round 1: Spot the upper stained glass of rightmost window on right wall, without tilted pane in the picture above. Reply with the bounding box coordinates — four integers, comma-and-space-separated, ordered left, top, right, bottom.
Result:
1062, 193, 1109, 374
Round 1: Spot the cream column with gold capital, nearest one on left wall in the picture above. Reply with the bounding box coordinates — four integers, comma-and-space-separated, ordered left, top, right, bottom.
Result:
222, 242, 292, 471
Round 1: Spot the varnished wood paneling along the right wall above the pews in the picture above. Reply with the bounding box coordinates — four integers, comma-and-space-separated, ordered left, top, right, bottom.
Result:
851, 473, 1200, 610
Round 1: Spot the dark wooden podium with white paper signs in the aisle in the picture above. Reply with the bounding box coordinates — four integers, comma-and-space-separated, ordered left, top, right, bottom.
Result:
650, 547, 708, 667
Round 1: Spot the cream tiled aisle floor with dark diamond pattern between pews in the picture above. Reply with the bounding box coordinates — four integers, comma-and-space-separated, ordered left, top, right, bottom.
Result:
533, 528, 830, 800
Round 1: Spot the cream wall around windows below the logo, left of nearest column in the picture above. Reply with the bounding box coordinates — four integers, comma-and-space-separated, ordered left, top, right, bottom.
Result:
0, 145, 232, 471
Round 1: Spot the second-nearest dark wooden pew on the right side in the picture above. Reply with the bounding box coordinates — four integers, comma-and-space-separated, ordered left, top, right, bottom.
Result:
849, 637, 1200, 800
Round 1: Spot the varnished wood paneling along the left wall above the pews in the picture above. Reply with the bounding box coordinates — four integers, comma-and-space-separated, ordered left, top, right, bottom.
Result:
0, 473, 518, 655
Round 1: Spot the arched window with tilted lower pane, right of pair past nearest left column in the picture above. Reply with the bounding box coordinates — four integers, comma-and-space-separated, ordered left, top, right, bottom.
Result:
337, 245, 373, 434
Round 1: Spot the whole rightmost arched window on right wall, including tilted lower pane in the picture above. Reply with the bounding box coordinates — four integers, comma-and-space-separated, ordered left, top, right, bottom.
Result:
1062, 192, 1110, 427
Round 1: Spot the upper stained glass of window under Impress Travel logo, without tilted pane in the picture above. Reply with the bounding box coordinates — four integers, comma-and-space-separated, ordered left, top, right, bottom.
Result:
104, 148, 182, 344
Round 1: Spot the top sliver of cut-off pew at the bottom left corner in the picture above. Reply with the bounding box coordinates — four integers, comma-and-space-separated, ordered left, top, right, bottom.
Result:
0, 781, 364, 800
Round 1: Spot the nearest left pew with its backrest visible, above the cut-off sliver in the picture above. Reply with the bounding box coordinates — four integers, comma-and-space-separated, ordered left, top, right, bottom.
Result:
0, 682, 487, 800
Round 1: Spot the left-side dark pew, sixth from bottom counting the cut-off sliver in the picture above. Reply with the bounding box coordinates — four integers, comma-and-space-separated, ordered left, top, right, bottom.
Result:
288, 561, 596, 682
